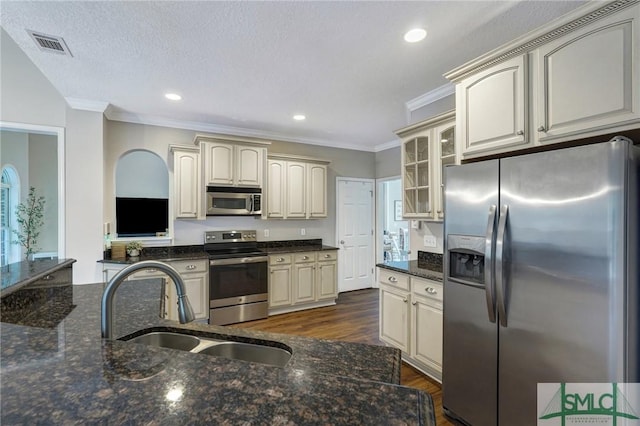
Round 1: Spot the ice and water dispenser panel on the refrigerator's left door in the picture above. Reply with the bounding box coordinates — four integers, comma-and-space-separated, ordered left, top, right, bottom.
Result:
447, 235, 485, 286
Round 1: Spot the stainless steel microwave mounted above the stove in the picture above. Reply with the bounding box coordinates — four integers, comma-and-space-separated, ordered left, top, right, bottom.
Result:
207, 186, 262, 216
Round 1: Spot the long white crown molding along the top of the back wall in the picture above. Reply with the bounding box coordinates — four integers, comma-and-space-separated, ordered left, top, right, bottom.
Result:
105, 108, 374, 152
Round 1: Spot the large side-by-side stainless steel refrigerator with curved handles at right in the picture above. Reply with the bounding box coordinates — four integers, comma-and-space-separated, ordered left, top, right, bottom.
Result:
442, 137, 640, 426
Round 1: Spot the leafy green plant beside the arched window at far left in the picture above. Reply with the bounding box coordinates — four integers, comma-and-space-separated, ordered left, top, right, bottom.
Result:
13, 186, 44, 259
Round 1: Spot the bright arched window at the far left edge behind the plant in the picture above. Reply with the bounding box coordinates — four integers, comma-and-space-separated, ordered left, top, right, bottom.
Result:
0, 166, 20, 266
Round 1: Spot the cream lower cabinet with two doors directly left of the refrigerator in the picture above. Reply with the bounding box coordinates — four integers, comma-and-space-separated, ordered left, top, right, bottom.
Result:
378, 268, 442, 381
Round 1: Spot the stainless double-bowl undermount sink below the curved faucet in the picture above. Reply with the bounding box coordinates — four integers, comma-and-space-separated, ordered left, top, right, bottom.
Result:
126, 331, 291, 367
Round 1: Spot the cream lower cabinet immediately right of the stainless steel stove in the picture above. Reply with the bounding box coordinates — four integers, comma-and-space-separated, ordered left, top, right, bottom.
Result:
269, 250, 338, 315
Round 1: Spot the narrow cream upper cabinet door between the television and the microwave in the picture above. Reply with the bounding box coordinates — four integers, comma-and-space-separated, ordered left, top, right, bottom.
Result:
173, 150, 202, 219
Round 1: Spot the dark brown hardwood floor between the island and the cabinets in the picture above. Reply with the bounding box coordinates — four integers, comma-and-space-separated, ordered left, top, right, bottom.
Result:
232, 289, 453, 426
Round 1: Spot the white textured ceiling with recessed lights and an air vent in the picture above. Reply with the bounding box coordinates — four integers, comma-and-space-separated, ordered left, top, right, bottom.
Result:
0, 1, 583, 151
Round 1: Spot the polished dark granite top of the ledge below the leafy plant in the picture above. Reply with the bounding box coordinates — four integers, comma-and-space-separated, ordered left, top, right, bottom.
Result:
0, 257, 76, 297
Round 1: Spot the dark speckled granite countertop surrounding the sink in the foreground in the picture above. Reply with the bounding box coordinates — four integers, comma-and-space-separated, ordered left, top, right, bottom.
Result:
0, 279, 435, 425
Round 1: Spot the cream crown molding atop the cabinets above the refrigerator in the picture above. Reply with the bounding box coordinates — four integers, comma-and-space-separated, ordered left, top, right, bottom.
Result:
444, 0, 640, 82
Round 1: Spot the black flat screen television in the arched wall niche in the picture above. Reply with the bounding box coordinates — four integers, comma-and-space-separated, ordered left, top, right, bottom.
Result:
116, 197, 169, 237
